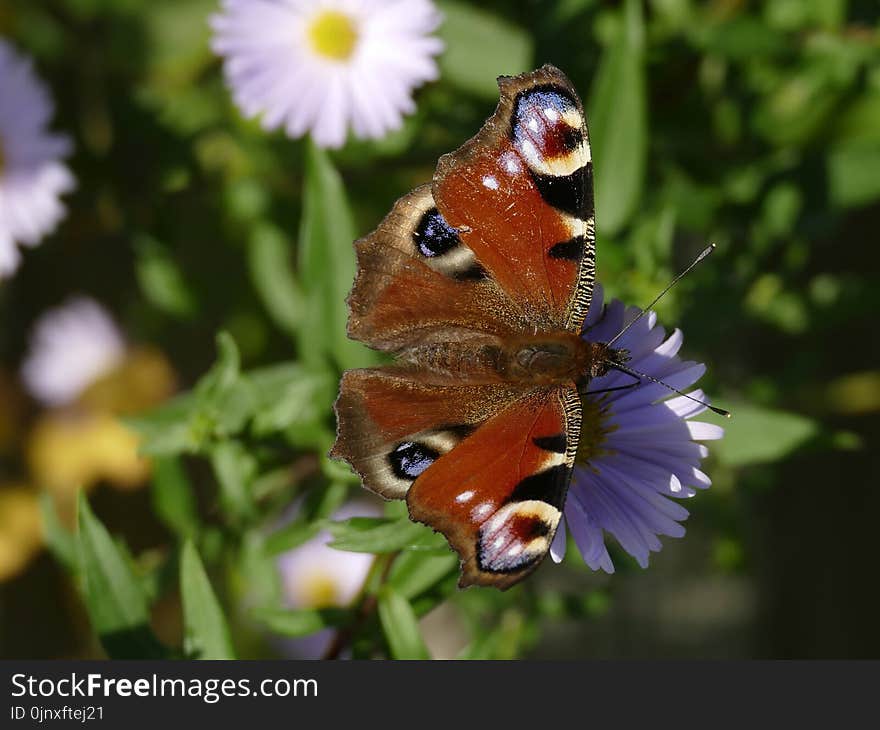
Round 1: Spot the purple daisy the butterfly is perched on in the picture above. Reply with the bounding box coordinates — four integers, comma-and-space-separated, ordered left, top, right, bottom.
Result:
550, 286, 724, 573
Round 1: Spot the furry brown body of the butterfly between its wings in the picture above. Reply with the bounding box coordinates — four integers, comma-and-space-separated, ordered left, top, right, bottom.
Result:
397, 332, 611, 386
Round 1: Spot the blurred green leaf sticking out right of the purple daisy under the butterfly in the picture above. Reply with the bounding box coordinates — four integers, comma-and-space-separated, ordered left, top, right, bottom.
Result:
700, 403, 820, 466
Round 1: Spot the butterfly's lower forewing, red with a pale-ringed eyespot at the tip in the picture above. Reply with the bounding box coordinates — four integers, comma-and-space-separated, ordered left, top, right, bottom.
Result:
406, 378, 581, 589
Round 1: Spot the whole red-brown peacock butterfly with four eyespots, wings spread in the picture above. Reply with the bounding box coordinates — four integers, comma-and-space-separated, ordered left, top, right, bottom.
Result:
331, 66, 627, 589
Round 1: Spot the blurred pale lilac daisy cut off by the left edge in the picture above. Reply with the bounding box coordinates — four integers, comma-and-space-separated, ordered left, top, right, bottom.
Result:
0, 39, 74, 279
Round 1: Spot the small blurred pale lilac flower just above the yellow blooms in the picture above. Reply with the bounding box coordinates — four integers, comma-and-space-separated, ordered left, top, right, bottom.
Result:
21, 297, 126, 406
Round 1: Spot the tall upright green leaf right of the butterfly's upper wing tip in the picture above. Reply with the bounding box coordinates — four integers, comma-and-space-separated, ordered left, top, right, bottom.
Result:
589, 0, 648, 235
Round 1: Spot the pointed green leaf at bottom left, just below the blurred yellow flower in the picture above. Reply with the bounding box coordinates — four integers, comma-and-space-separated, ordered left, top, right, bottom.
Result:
77, 493, 164, 659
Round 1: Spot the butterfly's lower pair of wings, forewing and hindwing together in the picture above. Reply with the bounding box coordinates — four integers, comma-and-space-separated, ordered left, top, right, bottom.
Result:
331, 368, 581, 588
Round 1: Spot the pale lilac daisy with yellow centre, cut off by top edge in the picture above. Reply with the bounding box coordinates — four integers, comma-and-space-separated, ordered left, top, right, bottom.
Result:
211, 0, 443, 147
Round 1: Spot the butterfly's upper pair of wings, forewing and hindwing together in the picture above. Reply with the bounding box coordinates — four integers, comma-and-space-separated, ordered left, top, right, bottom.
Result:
349, 66, 595, 352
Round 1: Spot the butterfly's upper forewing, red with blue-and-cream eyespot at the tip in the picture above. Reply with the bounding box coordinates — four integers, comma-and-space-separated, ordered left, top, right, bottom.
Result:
433, 66, 595, 332
